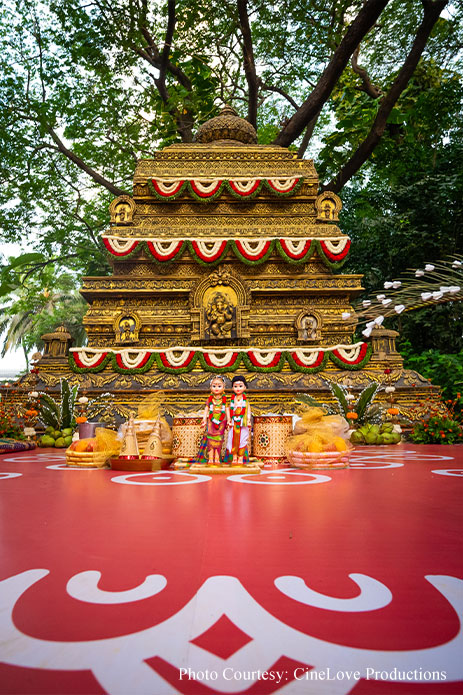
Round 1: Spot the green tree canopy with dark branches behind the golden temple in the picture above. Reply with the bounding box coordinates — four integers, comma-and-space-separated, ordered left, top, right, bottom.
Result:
0, 0, 463, 358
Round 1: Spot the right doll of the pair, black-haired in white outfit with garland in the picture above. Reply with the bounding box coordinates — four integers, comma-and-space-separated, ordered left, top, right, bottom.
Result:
225, 376, 251, 465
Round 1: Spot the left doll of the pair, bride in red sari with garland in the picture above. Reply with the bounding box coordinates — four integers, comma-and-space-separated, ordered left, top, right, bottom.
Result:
197, 374, 230, 466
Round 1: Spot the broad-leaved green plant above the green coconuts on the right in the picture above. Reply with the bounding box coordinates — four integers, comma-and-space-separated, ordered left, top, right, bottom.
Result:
295, 381, 383, 425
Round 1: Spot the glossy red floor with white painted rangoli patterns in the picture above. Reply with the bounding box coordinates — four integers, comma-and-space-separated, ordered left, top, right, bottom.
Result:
0, 444, 463, 695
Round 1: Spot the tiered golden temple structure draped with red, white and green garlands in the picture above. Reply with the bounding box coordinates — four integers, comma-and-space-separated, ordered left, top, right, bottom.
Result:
19, 107, 438, 417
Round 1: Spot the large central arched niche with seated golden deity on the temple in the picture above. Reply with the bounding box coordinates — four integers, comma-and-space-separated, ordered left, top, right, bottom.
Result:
190, 269, 251, 342
